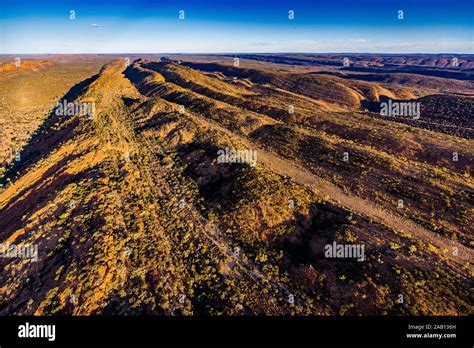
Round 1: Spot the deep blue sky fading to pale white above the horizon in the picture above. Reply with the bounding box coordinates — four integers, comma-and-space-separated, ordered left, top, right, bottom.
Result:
0, 0, 474, 54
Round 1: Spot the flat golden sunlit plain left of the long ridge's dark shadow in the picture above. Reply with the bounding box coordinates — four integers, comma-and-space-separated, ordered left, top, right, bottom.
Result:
0, 59, 103, 171
